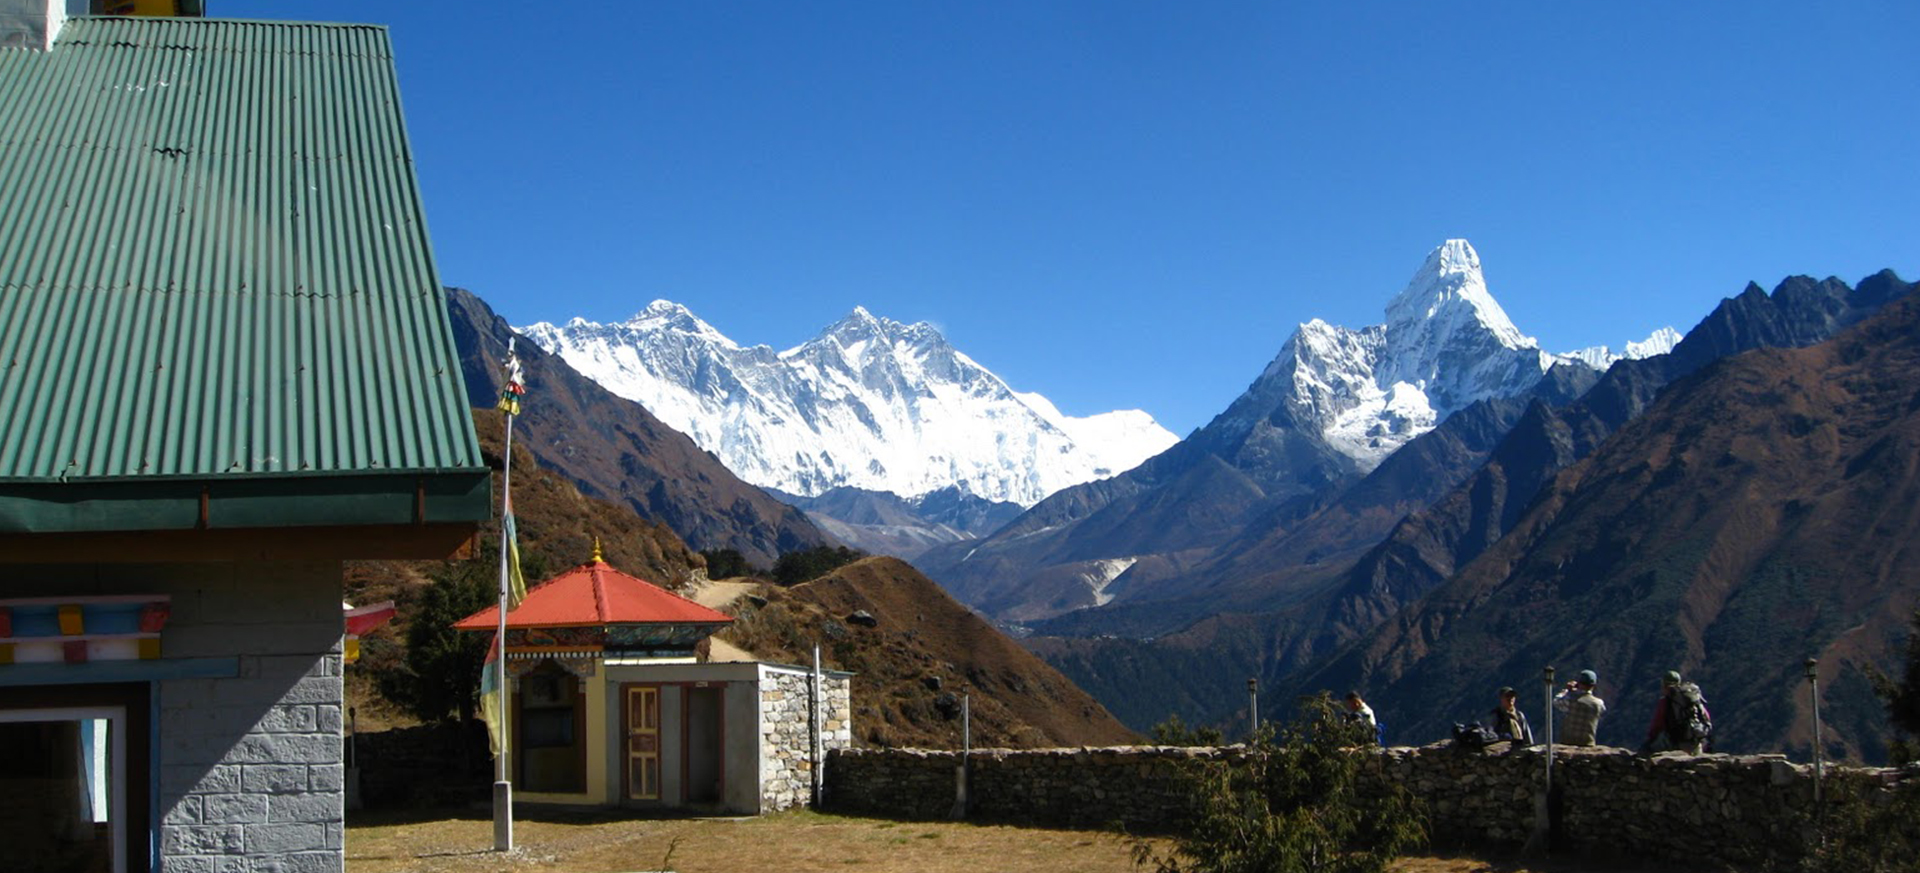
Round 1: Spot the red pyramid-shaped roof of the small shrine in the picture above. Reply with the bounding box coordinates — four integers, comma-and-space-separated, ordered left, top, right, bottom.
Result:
453, 560, 733, 631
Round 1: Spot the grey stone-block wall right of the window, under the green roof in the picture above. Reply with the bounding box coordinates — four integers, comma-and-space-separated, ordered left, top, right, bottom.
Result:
154, 562, 346, 873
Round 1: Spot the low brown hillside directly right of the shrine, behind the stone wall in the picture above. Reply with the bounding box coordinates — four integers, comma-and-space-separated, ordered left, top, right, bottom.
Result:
722, 558, 1139, 748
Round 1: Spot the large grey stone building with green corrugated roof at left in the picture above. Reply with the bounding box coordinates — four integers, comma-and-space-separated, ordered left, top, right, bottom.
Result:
0, 0, 490, 873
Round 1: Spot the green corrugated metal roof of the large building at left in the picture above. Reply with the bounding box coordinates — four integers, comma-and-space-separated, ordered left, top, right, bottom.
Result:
0, 17, 482, 533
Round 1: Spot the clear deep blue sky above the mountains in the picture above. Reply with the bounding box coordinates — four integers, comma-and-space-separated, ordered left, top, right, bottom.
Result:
224, 0, 1920, 434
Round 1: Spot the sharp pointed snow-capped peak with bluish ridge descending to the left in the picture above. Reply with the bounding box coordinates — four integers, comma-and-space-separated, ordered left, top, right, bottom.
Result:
922, 240, 1661, 622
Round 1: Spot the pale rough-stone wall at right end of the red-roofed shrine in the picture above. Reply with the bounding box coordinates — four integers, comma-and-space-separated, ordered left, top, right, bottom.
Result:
760, 670, 852, 812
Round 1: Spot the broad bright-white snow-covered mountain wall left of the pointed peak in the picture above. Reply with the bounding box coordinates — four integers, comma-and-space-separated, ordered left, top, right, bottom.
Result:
522, 301, 1175, 507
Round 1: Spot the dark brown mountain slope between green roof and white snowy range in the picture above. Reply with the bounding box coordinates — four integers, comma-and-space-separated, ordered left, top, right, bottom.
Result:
447, 288, 835, 566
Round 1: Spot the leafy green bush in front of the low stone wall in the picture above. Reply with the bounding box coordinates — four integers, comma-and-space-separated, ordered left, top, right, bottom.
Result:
1133, 693, 1427, 873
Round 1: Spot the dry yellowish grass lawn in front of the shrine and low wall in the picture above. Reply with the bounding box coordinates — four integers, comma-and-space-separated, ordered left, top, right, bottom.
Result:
348, 810, 1634, 873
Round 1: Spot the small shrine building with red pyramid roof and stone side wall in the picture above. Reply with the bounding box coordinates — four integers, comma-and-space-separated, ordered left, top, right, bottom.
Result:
453, 547, 852, 815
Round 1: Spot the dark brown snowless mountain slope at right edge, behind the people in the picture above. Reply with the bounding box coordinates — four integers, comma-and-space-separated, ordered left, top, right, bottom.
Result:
1304, 291, 1920, 758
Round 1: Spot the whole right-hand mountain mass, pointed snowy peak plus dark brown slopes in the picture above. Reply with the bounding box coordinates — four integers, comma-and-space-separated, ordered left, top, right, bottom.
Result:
441, 242, 1920, 756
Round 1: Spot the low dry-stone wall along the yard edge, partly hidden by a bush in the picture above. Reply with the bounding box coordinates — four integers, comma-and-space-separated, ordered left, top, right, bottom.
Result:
826, 744, 1920, 861
